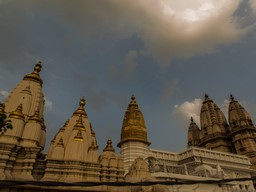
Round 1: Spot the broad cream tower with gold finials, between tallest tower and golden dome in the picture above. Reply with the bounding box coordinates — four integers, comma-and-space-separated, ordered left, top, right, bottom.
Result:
44, 97, 100, 181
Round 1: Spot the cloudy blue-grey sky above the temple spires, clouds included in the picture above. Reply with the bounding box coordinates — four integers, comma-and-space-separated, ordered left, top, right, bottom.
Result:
0, 0, 256, 153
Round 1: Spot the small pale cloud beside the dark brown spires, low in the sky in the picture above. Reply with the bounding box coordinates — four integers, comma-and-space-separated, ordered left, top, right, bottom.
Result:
172, 98, 202, 128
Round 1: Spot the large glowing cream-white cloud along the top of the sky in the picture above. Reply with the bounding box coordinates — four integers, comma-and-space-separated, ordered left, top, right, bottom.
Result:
43, 0, 250, 63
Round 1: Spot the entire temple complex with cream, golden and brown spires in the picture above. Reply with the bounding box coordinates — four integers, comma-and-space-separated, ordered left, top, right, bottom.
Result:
0, 62, 256, 192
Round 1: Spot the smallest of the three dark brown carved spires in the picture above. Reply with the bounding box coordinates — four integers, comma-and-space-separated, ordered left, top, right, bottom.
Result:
187, 117, 200, 147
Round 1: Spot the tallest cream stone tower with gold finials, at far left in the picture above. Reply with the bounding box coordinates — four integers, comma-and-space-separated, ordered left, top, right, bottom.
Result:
0, 62, 46, 179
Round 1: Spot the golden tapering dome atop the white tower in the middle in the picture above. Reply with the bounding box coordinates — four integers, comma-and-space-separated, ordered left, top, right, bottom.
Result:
117, 95, 150, 147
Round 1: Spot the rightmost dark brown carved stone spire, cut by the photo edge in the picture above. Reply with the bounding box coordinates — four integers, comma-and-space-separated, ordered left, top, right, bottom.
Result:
228, 95, 256, 169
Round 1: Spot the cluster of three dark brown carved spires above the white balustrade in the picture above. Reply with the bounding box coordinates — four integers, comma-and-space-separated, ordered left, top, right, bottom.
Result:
188, 95, 256, 169
